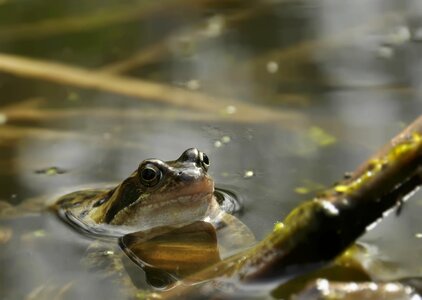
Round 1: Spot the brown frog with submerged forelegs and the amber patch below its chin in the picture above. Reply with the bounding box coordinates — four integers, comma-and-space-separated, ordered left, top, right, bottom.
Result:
50, 148, 255, 290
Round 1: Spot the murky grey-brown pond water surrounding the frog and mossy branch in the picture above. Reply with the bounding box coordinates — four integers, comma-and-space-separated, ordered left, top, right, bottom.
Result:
0, 0, 422, 299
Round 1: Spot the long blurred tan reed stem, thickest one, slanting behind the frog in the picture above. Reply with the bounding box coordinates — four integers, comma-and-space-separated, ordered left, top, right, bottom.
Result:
0, 54, 304, 122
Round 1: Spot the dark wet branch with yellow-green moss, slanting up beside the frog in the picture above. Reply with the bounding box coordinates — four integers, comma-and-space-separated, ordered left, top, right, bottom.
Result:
160, 117, 422, 299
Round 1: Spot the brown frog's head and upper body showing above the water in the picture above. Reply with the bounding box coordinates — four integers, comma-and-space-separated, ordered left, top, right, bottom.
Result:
52, 148, 253, 244
